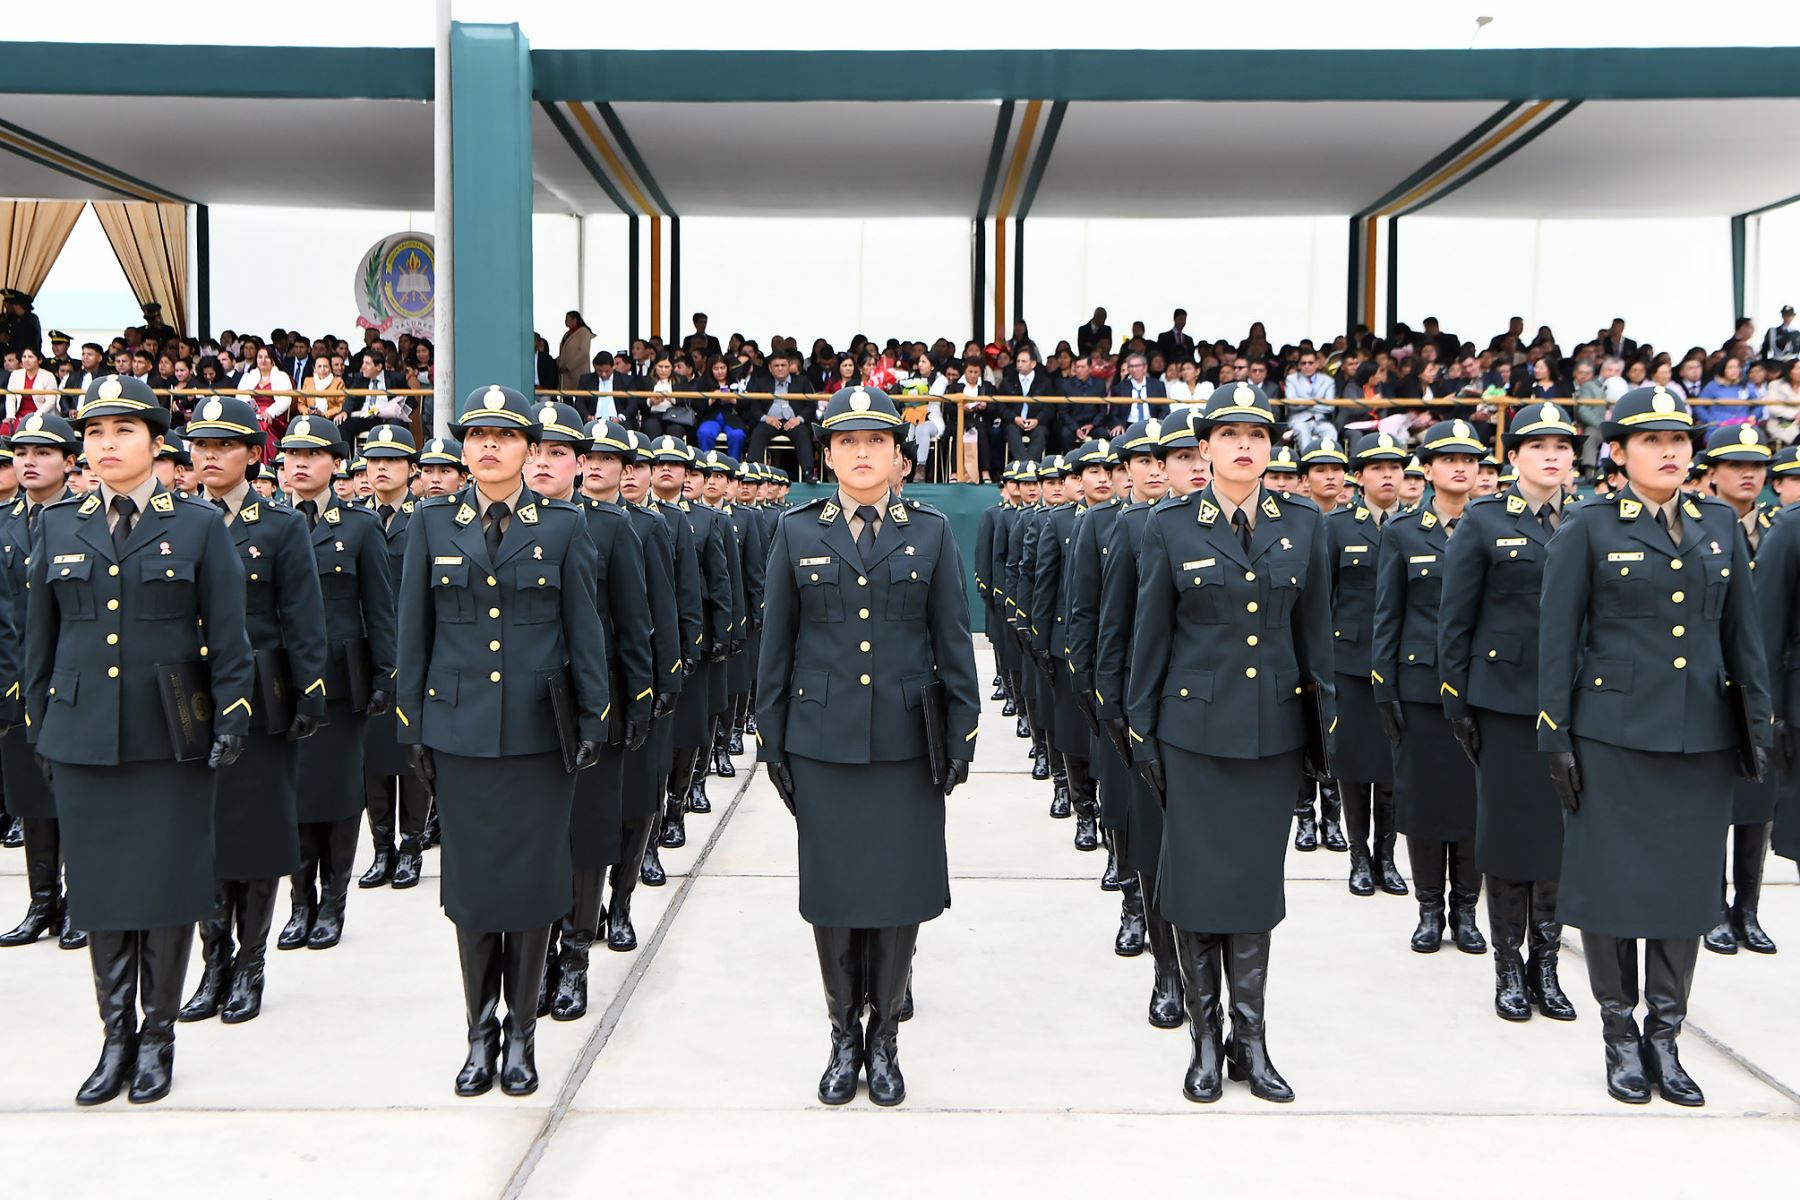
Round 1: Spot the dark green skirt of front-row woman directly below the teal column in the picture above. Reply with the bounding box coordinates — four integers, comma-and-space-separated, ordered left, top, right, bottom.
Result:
432, 750, 574, 934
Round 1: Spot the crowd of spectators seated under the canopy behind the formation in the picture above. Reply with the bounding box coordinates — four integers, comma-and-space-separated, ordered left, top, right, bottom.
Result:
0, 293, 1800, 480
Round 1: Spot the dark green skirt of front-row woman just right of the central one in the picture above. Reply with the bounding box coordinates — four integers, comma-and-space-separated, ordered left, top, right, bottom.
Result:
1156, 741, 1300, 934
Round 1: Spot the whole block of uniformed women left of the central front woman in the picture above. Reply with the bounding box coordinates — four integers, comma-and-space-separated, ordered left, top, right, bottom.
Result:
0, 378, 802, 1105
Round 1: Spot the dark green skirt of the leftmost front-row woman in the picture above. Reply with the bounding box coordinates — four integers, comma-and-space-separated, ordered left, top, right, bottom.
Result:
56, 763, 218, 930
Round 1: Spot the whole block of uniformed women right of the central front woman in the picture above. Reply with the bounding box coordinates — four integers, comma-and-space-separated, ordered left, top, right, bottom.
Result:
976, 385, 1800, 1105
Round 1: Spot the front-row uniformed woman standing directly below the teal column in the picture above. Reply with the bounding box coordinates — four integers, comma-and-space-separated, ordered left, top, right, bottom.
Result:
394, 385, 610, 1096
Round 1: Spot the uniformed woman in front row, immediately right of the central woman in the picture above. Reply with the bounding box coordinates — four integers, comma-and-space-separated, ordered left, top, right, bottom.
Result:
1125, 383, 1332, 1103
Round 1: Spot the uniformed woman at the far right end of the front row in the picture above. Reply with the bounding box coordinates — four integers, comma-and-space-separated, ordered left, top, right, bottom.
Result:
1537, 387, 1771, 1105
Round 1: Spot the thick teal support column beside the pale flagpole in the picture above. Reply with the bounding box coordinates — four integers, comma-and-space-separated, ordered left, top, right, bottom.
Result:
450, 22, 535, 408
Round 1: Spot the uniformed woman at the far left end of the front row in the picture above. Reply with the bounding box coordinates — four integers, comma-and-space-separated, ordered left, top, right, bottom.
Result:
23, 376, 252, 1105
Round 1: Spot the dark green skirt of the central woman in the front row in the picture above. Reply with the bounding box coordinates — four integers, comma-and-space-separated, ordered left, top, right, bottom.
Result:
788, 754, 950, 928
